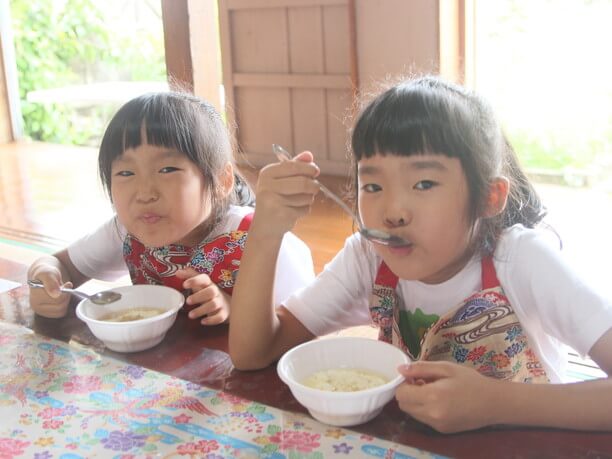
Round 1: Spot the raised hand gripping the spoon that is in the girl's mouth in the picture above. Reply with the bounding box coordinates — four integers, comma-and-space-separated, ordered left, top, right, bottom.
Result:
251, 151, 319, 235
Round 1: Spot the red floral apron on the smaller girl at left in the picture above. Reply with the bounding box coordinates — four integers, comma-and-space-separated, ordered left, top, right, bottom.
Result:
123, 214, 253, 306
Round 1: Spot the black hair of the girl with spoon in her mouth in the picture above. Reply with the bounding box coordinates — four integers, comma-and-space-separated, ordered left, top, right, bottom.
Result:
351, 76, 546, 254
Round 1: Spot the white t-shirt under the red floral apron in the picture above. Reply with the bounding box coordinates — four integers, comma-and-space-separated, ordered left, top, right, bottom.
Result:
68, 206, 314, 305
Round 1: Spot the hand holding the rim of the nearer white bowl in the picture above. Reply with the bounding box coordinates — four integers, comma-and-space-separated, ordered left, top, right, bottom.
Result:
395, 362, 501, 433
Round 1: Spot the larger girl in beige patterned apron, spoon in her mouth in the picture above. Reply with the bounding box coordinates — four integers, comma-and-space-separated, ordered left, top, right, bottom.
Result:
230, 77, 612, 432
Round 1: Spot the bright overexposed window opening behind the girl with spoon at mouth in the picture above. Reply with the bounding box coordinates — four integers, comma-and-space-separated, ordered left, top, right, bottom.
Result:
472, 0, 612, 288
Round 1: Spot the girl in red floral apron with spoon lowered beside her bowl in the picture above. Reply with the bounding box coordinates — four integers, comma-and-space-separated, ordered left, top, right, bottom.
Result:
28, 92, 314, 325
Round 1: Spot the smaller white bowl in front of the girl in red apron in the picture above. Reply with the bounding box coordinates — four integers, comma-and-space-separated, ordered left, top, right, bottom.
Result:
76, 285, 185, 352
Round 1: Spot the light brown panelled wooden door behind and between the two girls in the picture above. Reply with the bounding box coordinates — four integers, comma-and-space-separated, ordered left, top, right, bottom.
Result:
219, 0, 358, 174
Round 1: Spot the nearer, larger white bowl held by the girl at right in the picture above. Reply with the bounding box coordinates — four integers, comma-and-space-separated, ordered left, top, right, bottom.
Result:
277, 337, 410, 426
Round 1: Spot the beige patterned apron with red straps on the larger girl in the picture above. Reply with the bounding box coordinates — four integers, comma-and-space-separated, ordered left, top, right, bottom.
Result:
370, 257, 549, 382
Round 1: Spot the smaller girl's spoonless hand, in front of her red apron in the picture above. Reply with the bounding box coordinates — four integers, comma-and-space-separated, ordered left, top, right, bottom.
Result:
176, 268, 230, 325
